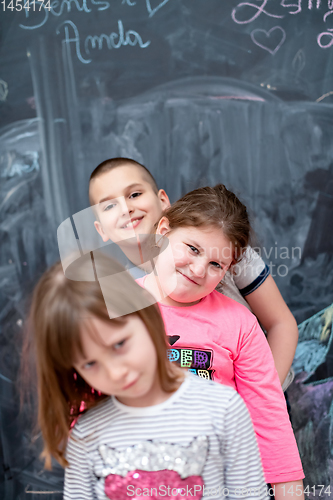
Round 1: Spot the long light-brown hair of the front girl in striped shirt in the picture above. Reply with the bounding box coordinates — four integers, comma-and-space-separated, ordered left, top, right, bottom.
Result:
24, 252, 182, 468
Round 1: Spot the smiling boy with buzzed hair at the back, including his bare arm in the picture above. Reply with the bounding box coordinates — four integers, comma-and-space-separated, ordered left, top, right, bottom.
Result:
89, 158, 298, 390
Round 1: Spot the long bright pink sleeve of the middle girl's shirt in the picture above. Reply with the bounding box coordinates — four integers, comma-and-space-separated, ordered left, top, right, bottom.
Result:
234, 320, 304, 483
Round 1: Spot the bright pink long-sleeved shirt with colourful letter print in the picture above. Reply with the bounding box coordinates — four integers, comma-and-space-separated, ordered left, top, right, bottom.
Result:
137, 278, 304, 483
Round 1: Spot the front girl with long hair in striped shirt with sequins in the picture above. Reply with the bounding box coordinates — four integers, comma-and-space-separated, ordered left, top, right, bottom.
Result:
24, 252, 266, 500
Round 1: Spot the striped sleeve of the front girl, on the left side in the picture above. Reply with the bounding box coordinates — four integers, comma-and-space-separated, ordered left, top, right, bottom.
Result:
64, 427, 97, 500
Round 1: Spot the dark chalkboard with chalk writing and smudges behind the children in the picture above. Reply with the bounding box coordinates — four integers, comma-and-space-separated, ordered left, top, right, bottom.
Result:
0, 0, 333, 500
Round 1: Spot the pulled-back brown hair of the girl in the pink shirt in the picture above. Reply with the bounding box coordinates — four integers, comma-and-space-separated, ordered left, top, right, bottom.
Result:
161, 184, 251, 264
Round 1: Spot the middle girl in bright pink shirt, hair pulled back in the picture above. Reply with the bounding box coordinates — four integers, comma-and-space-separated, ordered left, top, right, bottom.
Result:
138, 185, 304, 500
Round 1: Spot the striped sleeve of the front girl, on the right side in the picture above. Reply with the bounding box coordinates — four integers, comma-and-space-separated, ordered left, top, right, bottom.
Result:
221, 393, 267, 500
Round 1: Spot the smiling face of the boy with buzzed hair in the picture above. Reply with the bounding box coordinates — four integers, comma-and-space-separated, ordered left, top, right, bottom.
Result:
89, 165, 170, 242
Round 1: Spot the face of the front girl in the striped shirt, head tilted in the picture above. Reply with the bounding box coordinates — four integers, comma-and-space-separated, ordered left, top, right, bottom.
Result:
74, 314, 164, 406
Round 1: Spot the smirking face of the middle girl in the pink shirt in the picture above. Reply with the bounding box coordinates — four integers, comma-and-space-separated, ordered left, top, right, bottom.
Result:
156, 217, 234, 306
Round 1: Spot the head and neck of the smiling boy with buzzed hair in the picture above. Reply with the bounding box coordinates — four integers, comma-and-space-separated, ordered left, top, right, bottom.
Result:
89, 158, 170, 278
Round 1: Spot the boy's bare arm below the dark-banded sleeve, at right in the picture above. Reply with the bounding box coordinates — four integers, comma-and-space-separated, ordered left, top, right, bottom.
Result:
245, 275, 298, 385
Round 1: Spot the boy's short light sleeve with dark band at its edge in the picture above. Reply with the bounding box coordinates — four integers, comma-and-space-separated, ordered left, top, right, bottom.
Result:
233, 247, 269, 297
